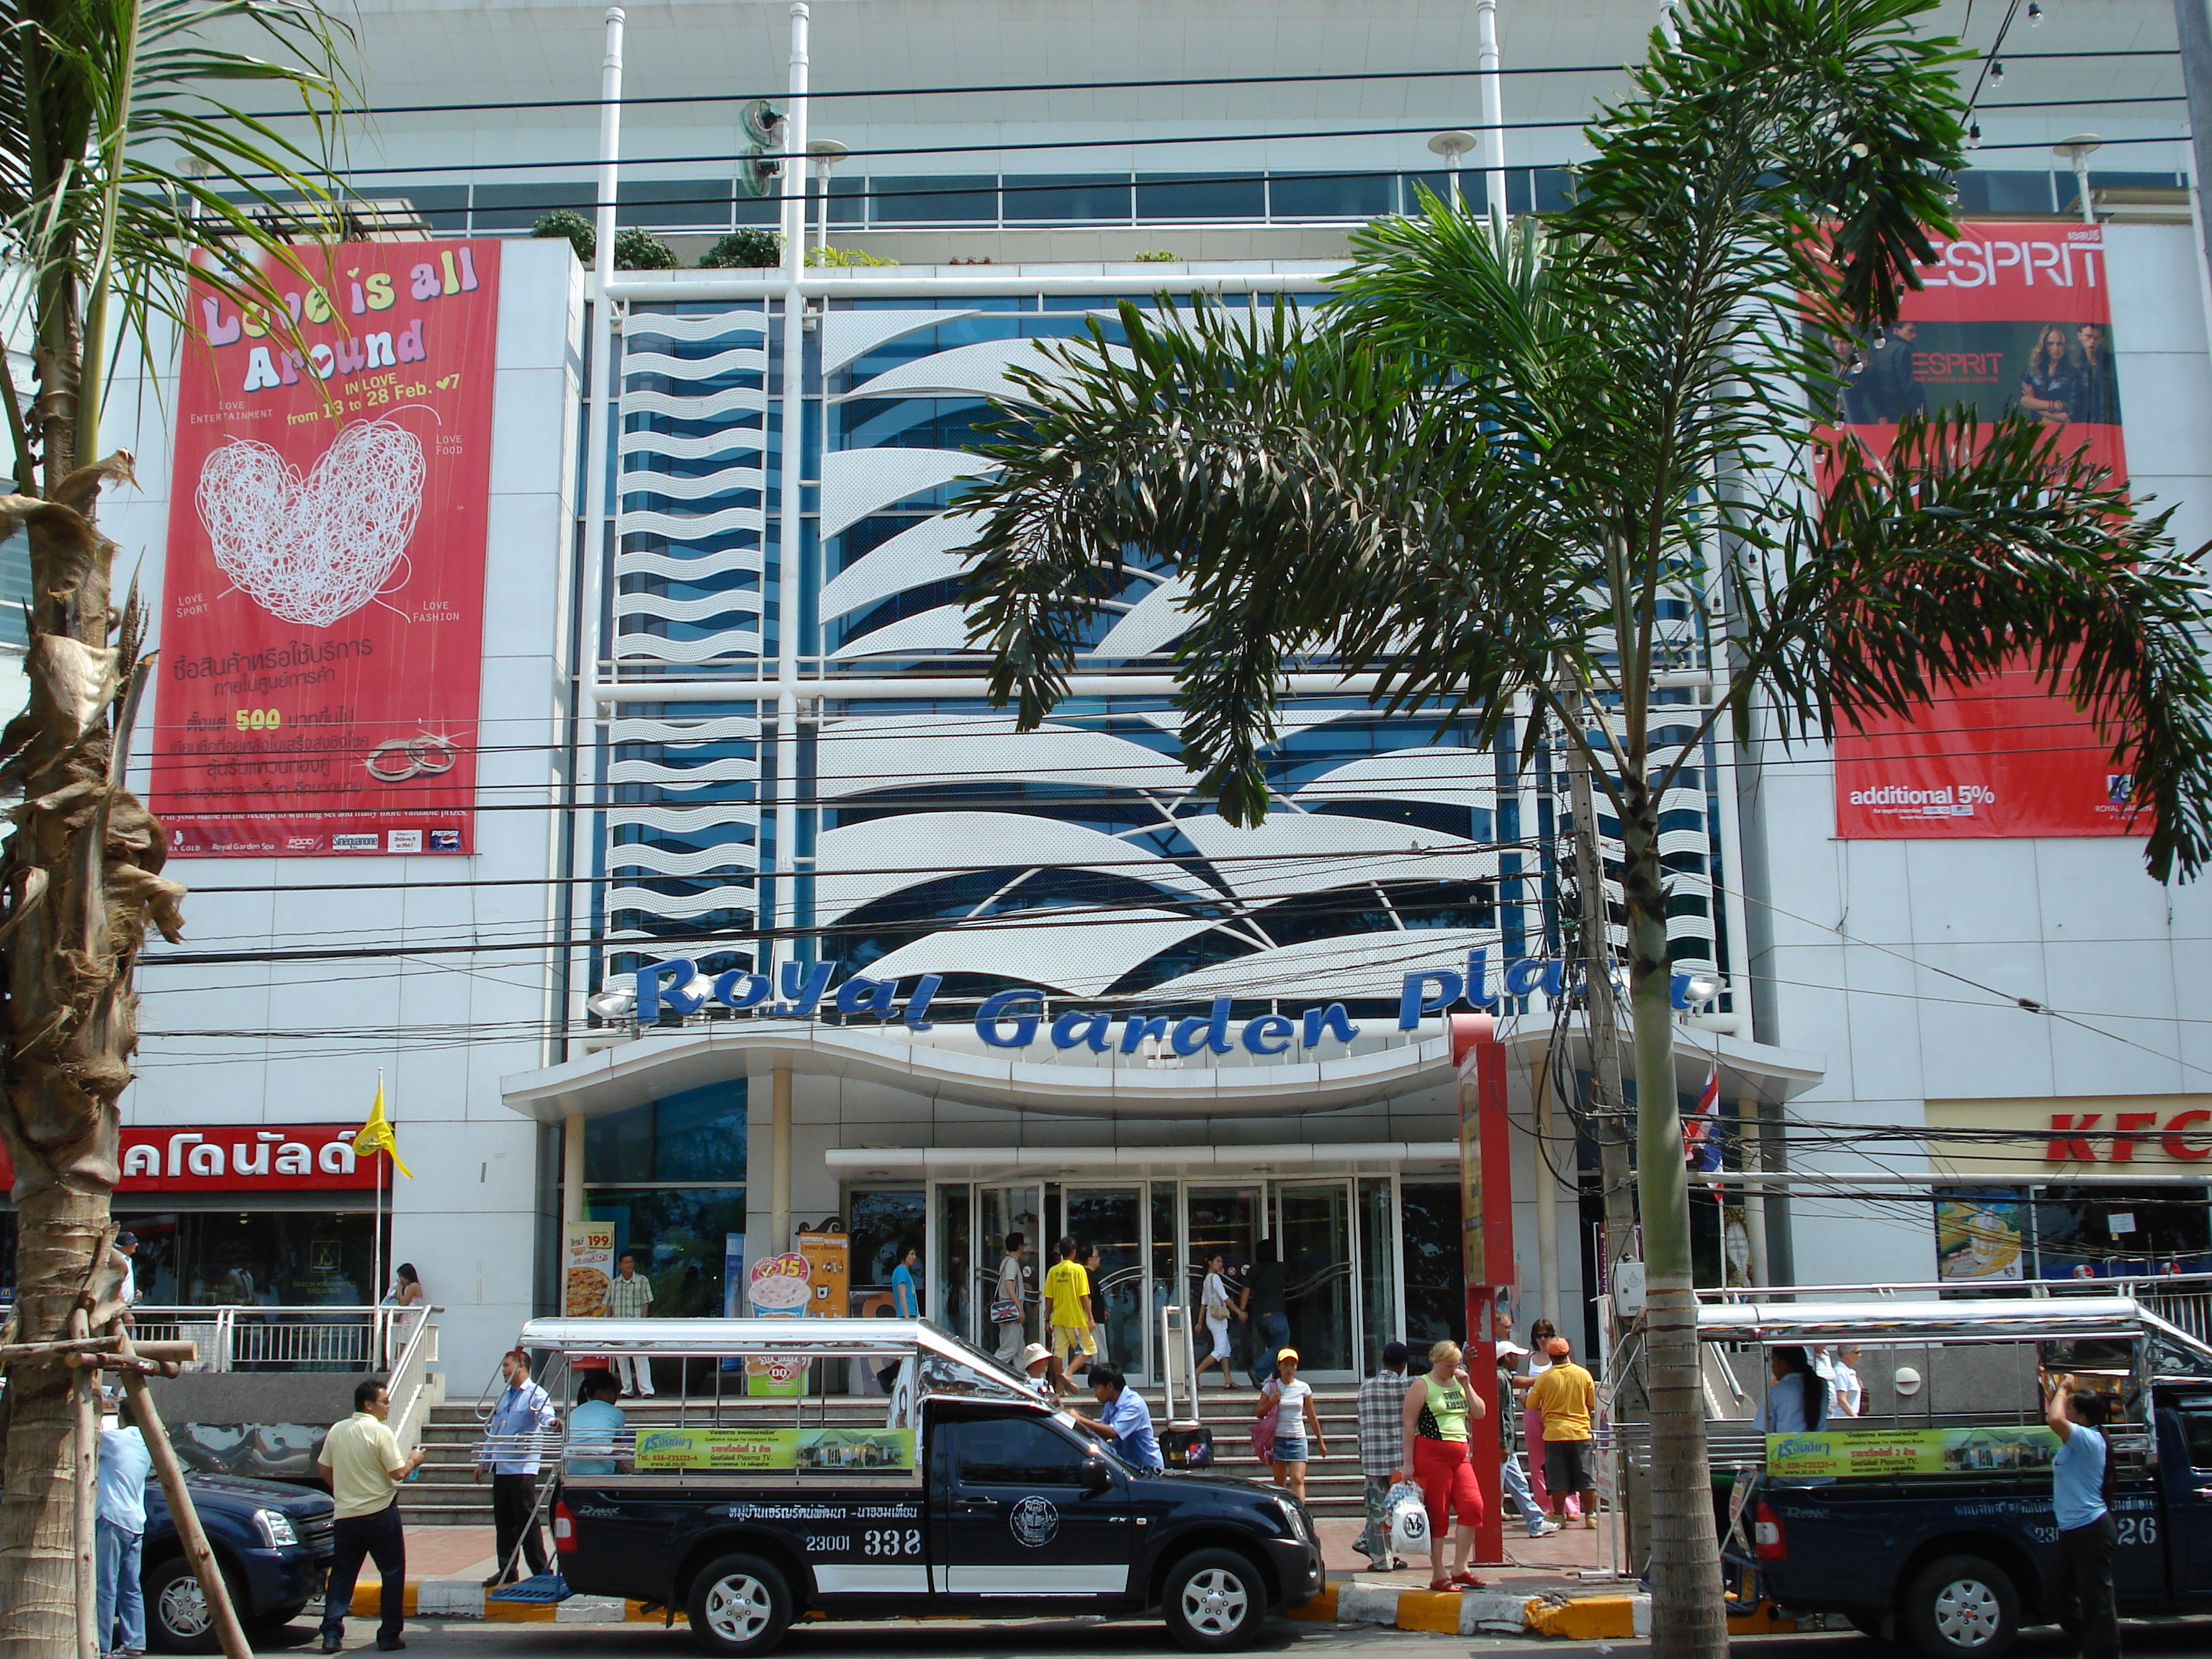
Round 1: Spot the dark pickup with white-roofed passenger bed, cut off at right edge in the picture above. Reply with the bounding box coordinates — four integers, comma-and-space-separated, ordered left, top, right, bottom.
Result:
1699, 1285, 2212, 1659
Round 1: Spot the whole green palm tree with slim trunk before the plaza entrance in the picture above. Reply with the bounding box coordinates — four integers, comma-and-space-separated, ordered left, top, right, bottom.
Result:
969, 0, 2212, 1655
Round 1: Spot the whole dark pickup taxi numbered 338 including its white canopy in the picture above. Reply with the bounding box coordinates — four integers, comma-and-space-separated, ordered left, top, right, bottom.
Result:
508, 1318, 1323, 1655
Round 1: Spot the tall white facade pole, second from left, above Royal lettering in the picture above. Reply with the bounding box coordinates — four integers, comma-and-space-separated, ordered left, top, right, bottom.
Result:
761, 0, 809, 986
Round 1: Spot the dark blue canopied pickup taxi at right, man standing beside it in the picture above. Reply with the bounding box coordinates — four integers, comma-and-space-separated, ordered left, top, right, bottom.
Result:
1701, 1296, 2212, 1659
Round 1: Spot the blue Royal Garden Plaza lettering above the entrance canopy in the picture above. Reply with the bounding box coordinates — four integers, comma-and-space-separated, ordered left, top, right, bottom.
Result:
635, 951, 1716, 1057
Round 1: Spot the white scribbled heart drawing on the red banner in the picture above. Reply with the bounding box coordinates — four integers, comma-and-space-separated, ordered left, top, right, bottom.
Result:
199, 421, 423, 628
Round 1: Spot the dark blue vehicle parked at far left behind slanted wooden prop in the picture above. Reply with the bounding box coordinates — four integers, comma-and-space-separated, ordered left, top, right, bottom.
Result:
140, 1475, 332, 1653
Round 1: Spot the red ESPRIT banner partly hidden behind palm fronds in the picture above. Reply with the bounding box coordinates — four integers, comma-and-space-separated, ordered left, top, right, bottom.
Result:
1836, 221, 2144, 840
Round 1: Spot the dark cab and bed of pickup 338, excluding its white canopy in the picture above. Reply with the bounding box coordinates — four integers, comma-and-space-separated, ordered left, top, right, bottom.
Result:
553, 1395, 1323, 1655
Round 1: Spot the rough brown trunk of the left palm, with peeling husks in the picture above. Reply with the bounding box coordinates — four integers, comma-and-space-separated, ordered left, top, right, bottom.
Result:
0, 498, 181, 1659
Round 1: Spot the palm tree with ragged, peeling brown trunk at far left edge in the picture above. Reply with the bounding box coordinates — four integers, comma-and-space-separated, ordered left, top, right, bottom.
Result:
0, 0, 345, 1655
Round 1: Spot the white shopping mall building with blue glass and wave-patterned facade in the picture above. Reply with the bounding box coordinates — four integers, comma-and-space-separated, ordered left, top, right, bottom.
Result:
4, 0, 2212, 1391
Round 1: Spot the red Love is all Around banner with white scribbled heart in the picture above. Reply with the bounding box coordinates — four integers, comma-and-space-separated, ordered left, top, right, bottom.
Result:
150, 241, 500, 858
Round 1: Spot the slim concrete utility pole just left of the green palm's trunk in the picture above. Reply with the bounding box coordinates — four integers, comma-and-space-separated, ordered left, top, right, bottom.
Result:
1566, 695, 1650, 1562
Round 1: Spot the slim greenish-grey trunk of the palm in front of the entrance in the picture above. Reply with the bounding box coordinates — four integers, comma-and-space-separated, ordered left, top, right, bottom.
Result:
1622, 814, 1727, 1659
